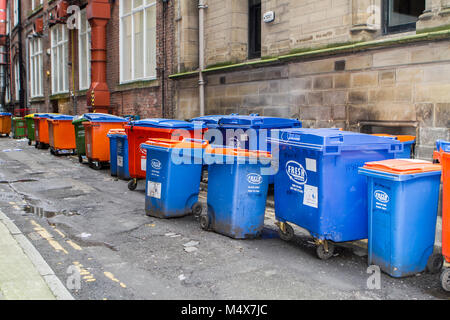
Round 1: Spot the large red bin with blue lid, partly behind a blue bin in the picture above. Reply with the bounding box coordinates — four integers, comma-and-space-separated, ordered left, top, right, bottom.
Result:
125, 118, 205, 190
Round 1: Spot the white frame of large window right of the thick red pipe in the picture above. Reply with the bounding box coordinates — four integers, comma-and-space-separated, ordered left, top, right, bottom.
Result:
119, 0, 157, 84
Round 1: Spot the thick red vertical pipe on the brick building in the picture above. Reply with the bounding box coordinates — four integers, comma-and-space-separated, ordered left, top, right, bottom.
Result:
86, 0, 111, 113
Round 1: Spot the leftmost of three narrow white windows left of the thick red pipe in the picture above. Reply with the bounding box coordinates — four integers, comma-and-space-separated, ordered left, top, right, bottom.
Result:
29, 38, 44, 98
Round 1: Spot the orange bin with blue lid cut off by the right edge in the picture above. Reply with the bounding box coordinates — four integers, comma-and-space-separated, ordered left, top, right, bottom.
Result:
438, 141, 450, 292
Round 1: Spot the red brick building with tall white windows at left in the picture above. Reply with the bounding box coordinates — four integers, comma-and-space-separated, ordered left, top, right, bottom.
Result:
5, 0, 175, 118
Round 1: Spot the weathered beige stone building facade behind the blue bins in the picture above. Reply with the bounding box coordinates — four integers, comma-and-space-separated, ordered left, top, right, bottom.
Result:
170, 0, 450, 159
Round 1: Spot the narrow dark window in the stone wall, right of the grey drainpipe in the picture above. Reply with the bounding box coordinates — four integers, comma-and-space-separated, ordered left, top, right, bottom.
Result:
248, 0, 261, 59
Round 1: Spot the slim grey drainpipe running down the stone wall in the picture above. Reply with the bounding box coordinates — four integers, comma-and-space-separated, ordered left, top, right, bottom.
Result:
198, 0, 208, 116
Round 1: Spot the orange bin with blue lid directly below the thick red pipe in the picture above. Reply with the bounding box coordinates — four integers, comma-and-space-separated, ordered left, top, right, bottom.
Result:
83, 113, 128, 170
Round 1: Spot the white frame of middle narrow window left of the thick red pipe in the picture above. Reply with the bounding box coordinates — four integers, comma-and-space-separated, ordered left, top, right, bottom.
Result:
50, 24, 69, 95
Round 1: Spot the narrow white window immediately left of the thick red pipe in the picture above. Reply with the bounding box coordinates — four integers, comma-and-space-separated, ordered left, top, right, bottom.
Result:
78, 10, 91, 90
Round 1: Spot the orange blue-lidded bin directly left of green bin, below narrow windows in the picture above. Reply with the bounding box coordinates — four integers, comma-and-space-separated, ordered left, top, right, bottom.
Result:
47, 114, 77, 156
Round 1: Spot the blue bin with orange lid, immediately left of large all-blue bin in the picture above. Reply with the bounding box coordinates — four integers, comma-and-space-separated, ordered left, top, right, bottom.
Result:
200, 147, 272, 239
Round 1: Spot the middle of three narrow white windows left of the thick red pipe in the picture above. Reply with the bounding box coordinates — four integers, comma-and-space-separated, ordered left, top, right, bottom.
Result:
51, 24, 69, 94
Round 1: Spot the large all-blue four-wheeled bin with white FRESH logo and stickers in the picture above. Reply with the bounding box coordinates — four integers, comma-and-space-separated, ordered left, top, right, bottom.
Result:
268, 129, 403, 260
